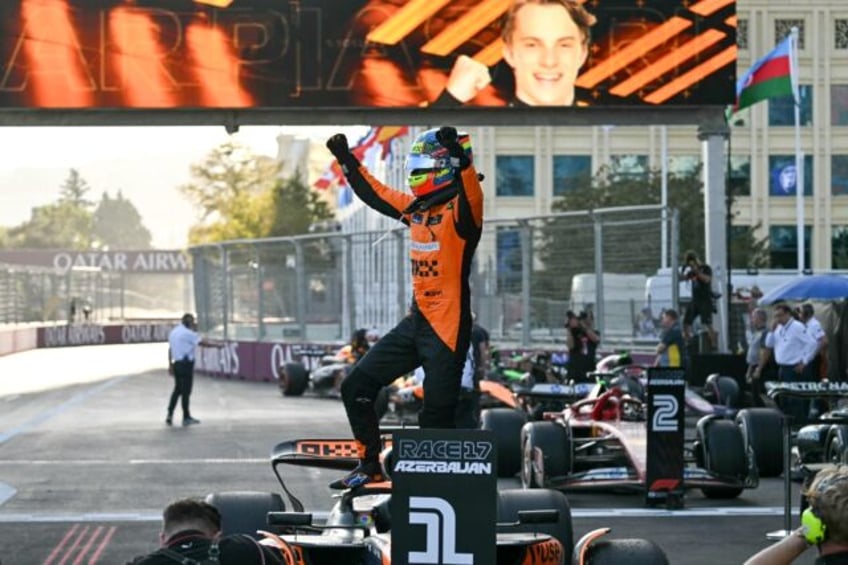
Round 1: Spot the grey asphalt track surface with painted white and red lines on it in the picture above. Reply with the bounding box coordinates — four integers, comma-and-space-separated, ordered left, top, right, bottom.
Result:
0, 344, 814, 565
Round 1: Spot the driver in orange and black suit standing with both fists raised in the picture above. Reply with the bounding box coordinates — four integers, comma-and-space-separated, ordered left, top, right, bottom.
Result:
327, 126, 483, 489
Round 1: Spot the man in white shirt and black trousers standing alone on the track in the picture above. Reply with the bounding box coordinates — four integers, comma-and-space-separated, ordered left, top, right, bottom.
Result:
165, 314, 203, 426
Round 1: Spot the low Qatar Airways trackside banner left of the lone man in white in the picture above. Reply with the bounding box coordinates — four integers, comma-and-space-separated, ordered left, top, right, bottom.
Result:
36, 322, 177, 349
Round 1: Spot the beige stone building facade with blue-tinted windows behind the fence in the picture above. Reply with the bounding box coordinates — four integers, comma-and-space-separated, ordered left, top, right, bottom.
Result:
332, 0, 848, 272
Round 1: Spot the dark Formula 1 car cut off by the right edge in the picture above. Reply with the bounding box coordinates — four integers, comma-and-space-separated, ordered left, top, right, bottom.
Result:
765, 381, 848, 468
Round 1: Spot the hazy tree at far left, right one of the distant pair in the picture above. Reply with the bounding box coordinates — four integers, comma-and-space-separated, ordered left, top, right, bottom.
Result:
92, 190, 152, 249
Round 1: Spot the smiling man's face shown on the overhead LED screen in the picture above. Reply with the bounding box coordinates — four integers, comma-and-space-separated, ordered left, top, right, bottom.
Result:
504, 4, 588, 106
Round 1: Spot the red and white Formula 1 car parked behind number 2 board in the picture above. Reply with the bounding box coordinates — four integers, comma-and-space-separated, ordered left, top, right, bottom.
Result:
521, 378, 779, 498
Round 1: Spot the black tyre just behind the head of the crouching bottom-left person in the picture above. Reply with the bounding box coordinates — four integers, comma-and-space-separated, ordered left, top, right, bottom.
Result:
205, 491, 286, 539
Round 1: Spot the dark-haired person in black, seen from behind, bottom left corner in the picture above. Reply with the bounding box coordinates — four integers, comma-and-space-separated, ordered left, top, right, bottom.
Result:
127, 498, 286, 565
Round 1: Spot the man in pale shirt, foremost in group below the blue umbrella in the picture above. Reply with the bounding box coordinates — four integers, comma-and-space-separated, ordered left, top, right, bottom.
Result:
765, 304, 818, 425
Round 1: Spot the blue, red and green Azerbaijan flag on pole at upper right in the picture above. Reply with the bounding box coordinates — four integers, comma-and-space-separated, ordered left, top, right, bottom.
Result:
733, 35, 798, 113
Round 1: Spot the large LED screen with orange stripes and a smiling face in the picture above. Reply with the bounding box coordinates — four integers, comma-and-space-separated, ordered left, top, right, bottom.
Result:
0, 0, 736, 109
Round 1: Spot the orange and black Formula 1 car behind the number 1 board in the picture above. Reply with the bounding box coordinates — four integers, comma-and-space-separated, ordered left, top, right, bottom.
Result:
207, 435, 573, 565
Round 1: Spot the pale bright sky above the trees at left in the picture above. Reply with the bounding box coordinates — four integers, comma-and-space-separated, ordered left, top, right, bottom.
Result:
0, 126, 362, 249
